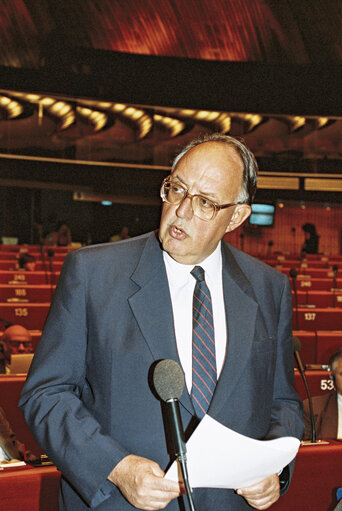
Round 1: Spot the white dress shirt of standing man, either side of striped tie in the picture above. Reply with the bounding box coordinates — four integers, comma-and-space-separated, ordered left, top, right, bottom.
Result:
163, 242, 227, 393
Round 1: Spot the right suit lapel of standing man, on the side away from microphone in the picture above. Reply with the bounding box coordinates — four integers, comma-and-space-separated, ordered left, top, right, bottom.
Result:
209, 244, 258, 416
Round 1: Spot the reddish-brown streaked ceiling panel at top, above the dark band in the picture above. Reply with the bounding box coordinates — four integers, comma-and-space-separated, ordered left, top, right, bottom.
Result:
0, 0, 342, 68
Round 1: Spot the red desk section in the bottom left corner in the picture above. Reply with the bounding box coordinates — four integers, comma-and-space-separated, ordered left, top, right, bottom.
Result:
0, 465, 60, 511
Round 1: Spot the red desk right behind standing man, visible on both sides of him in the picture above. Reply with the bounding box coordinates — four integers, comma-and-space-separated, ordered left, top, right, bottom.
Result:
0, 440, 342, 511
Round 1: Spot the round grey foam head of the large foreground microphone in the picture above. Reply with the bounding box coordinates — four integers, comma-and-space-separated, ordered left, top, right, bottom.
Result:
153, 359, 184, 401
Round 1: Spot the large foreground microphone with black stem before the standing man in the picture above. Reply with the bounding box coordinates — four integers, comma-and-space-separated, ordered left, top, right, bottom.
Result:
153, 359, 195, 511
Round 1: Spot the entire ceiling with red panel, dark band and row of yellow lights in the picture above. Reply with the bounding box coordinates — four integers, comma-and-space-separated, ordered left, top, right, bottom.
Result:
0, 0, 342, 204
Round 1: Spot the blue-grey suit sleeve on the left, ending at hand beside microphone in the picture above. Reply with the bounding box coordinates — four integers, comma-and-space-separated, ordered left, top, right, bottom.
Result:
19, 252, 129, 505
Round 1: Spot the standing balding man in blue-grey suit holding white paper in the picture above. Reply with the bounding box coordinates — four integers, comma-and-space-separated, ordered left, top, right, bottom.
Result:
20, 134, 303, 511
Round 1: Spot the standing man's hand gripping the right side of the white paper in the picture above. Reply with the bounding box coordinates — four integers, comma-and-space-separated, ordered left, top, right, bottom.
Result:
236, 474, 280, 509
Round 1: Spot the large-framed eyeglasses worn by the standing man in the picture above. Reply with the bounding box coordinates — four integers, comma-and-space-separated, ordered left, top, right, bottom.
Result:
160, 176, 240, 221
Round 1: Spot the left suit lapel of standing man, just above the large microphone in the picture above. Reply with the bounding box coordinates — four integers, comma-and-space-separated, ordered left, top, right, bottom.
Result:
128, 233, 193, 413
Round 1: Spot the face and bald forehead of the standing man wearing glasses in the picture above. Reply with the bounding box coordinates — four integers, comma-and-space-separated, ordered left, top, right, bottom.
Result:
159, 142, 251, 264
